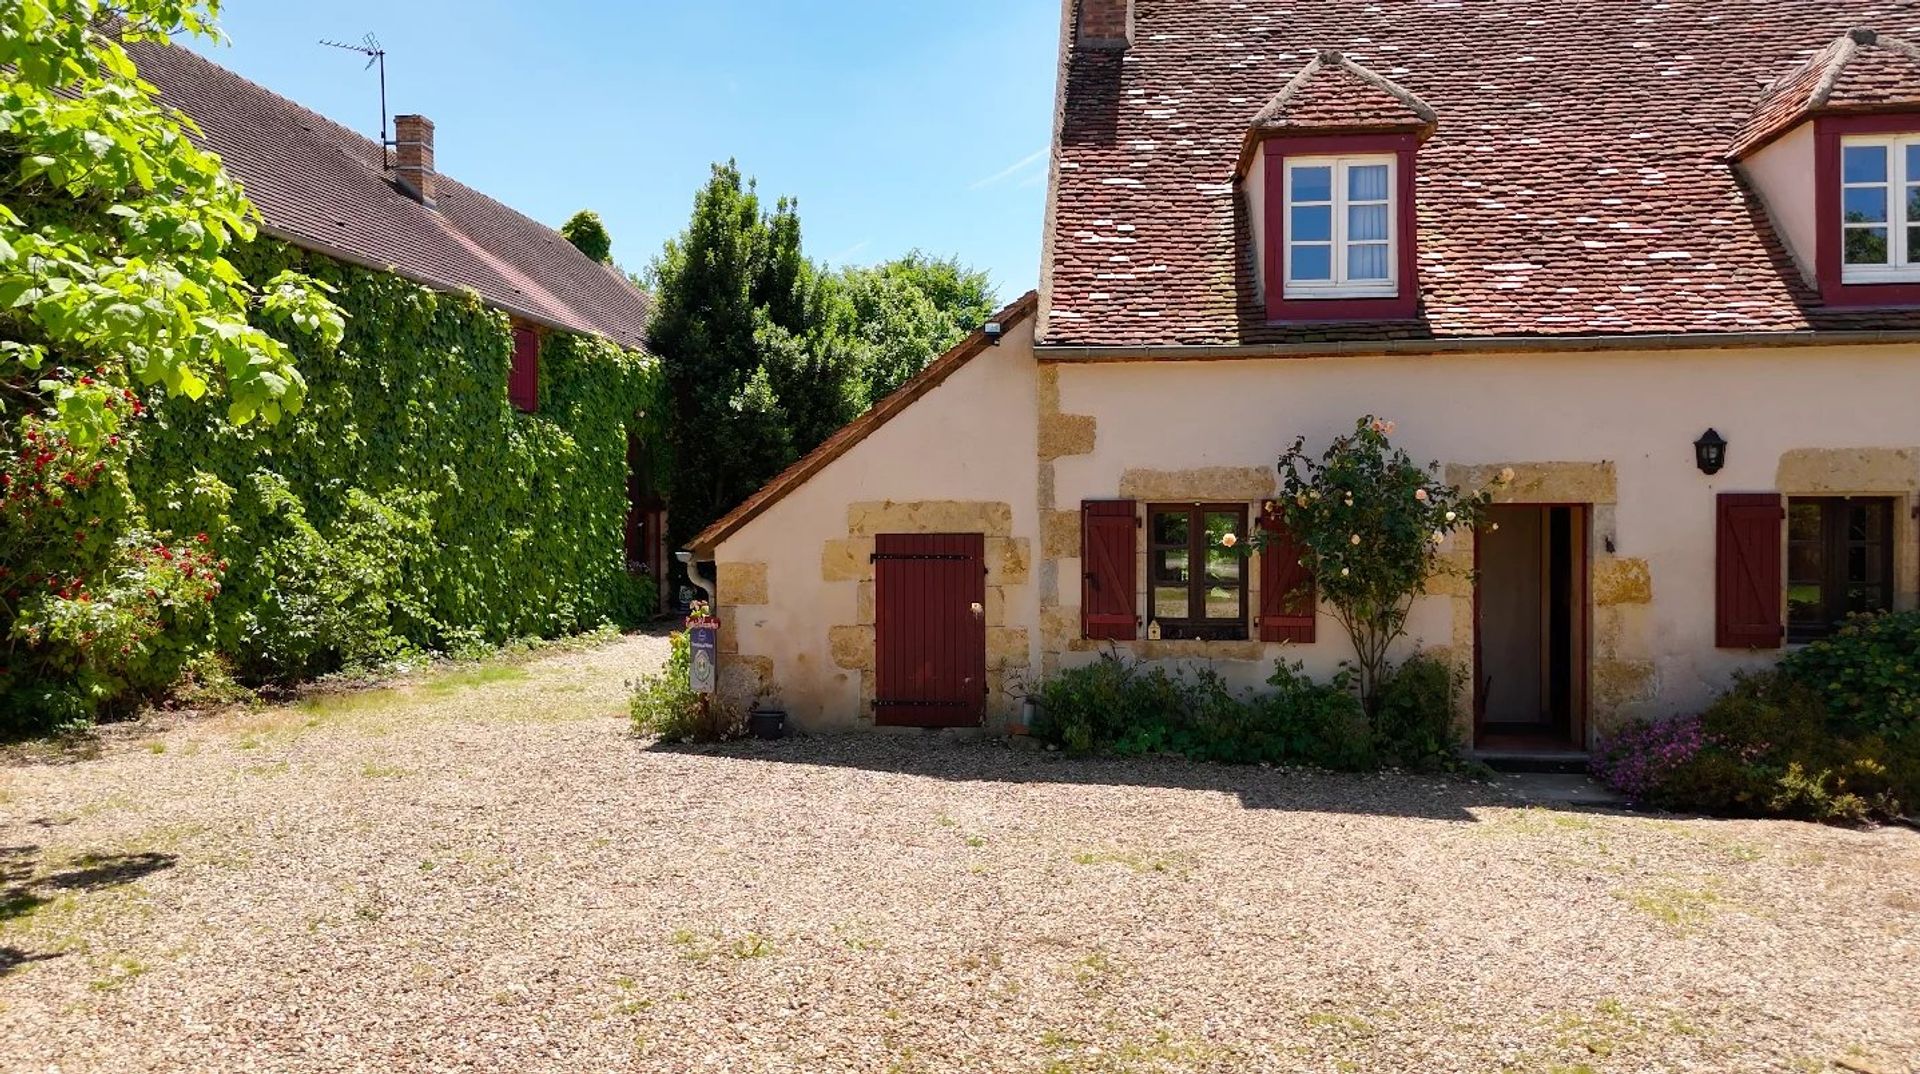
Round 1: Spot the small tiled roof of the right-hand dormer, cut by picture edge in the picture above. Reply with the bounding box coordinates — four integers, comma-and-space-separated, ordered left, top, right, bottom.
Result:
1728, 29, 1920, 159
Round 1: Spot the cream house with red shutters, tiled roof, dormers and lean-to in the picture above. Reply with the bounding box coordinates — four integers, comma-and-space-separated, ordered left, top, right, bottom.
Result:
691, 0, 1920, 751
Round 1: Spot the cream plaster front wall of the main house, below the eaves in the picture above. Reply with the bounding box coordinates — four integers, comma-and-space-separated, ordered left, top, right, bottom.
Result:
1043, 346, 1920, 722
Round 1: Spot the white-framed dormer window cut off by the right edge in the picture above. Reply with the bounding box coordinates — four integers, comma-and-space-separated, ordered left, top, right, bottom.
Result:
1839, 134, 1920, 284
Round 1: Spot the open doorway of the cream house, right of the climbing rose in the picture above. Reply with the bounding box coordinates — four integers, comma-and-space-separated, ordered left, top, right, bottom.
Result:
1473, 503, 1588, 753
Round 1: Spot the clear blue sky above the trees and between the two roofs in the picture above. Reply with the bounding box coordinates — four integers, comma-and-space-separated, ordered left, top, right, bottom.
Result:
210, 0, 1060, 300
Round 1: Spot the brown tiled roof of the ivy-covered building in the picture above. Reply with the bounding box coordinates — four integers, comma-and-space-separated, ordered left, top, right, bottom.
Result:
129, 42, 649, 348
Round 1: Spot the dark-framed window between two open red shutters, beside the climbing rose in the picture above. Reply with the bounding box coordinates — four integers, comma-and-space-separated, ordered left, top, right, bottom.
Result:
1146, 503, 1246, 642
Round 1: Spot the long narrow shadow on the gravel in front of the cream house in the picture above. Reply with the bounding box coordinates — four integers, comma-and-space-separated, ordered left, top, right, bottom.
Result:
647, 734, 1551, 822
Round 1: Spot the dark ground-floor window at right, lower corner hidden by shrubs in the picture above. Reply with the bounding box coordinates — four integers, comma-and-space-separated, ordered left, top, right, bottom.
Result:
1788, 498, 1893, 644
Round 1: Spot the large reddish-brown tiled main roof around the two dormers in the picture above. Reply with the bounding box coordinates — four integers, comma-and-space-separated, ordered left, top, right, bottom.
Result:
1043, 0, 1920, 346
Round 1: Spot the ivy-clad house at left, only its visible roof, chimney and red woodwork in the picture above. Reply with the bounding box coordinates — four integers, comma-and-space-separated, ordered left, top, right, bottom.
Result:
129, 42, 668, 590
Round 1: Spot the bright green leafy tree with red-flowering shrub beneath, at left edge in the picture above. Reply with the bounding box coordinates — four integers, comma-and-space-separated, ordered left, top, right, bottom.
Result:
0, 0, 344, 722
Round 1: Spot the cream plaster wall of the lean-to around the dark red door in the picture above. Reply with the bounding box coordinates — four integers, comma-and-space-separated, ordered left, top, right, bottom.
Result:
714, 317, 1039, 730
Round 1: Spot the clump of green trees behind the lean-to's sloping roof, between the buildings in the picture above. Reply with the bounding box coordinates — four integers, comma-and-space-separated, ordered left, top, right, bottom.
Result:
647, 161, 991, 540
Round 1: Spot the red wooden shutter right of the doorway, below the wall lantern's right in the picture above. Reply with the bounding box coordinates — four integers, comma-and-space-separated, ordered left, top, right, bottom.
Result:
1713, 492, 1788, 649
